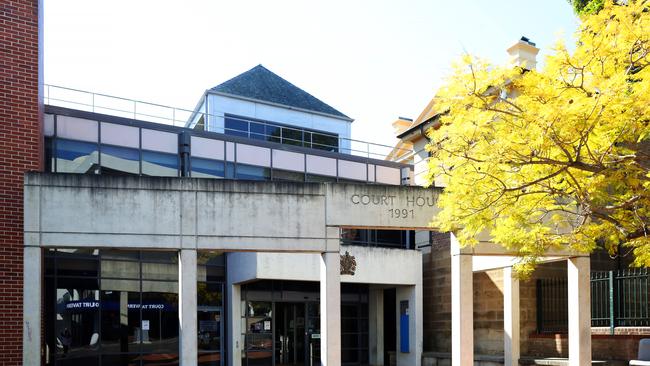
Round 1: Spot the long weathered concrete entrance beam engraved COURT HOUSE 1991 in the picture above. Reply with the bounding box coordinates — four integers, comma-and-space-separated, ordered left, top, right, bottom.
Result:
25, 173, 439, 253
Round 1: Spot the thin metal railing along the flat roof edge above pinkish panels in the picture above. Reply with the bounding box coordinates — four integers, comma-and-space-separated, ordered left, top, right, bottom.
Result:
44, 84, 413, 160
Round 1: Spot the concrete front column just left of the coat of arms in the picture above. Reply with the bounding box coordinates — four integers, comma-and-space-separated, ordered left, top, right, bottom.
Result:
320, 251, 341, 366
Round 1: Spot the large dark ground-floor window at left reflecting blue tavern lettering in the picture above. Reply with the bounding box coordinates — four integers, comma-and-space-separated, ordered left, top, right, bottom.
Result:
44, 249, 179, 366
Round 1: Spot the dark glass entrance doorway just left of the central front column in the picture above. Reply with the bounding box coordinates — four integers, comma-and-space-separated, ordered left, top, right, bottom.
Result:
275, 302, 307, 366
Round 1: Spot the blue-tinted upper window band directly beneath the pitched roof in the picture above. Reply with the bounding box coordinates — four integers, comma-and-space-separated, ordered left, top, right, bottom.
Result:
224, 115, 339, 152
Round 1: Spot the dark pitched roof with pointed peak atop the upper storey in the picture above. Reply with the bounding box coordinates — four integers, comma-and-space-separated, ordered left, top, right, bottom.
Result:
210, 65, 351, 120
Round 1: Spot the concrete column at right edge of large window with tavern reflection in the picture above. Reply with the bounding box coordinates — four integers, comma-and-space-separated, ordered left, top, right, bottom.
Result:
178, 249, 198, 366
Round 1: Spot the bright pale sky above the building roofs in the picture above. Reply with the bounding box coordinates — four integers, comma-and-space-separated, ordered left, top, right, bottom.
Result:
44, 0, 578, 145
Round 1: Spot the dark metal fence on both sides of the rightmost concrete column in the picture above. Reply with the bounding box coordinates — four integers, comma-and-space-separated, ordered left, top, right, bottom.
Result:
537, 268, 650, 334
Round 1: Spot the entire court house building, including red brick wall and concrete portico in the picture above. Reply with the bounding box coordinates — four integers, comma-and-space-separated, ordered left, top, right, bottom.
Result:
0, 0, 650, 366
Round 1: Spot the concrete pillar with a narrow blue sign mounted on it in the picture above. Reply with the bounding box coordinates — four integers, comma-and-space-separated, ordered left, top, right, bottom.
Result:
395, 281, 424, 366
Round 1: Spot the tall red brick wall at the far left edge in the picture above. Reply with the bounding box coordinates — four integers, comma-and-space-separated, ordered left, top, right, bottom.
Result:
0, 0, 43, 366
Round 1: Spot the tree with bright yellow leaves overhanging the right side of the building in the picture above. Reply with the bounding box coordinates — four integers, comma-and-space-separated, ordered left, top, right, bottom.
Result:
428, 0, 650, 276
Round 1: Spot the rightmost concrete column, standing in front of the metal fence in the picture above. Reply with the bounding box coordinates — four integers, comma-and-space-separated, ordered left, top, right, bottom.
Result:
567, 257, 591, 366
